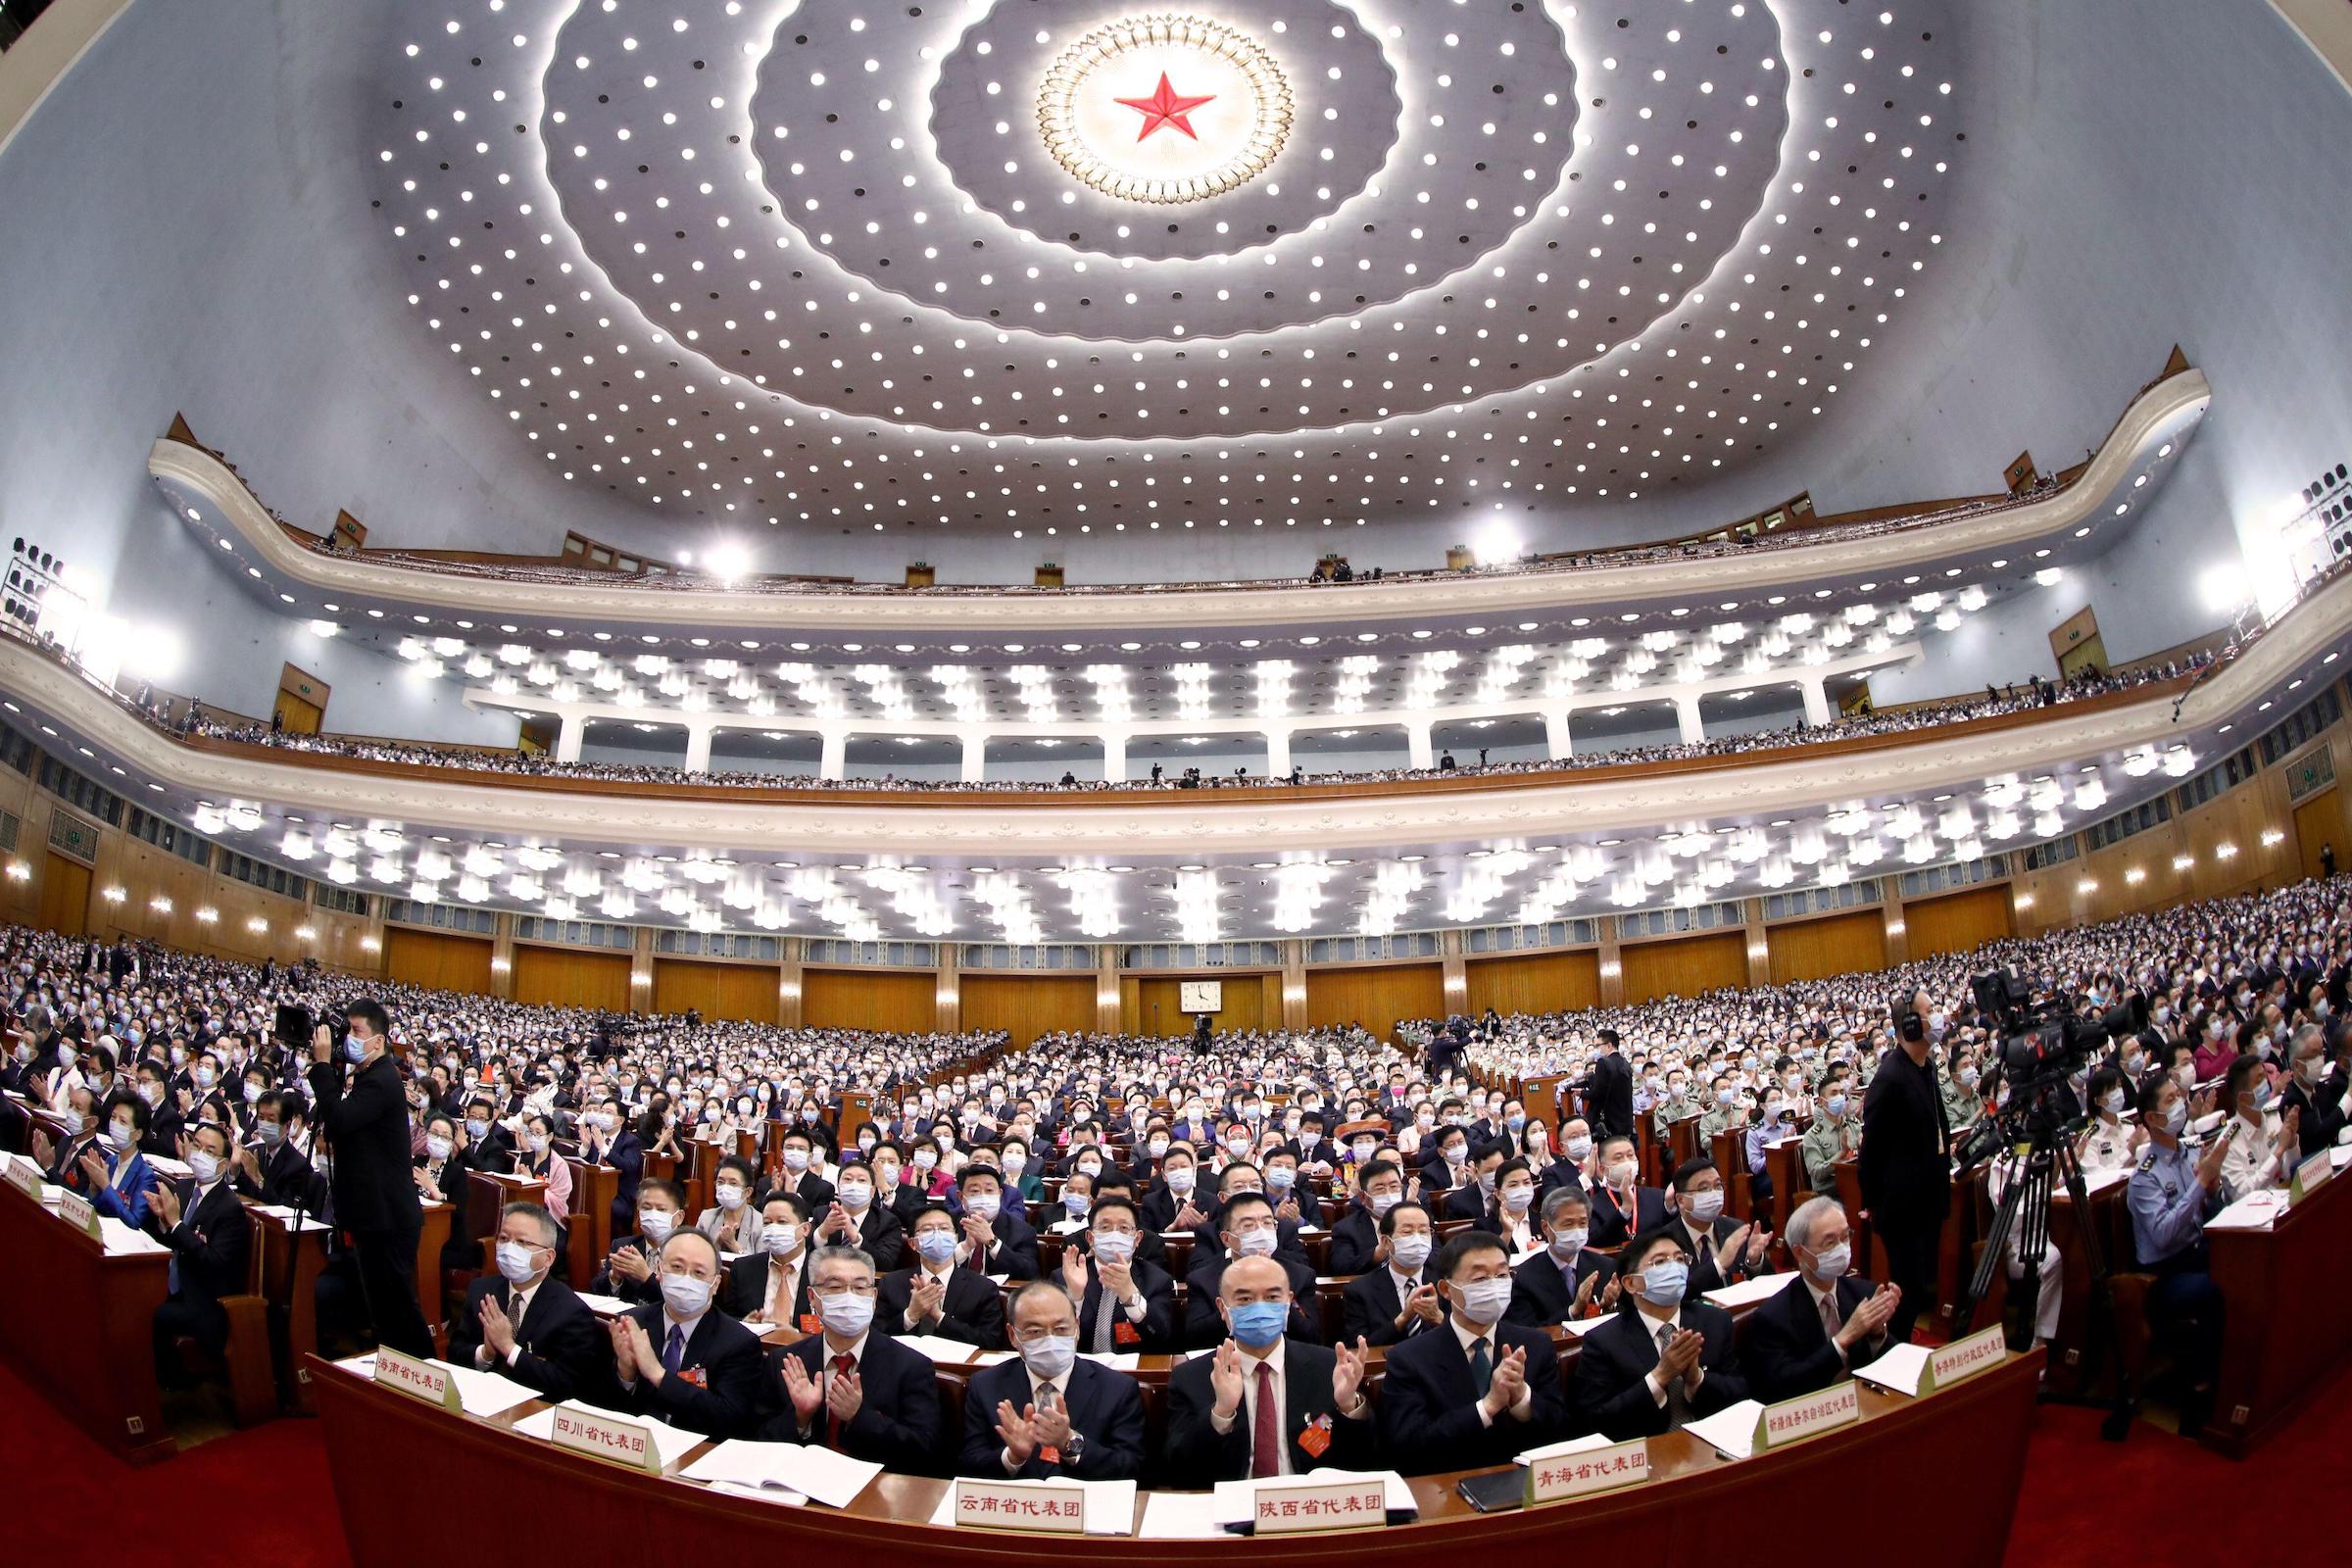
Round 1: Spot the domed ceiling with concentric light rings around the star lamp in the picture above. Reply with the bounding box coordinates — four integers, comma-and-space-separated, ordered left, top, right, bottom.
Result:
376, 0, 1962, 536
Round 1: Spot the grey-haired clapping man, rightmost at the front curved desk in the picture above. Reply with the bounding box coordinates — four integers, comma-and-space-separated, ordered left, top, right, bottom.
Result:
1742, 1197, 1900, 1403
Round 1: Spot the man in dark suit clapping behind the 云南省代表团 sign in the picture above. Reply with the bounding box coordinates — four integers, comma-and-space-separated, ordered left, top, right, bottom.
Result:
955, 1279, 1143, 1481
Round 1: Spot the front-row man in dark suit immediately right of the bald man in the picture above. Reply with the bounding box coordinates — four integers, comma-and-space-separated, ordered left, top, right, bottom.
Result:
1381, 1230, 1569, 1474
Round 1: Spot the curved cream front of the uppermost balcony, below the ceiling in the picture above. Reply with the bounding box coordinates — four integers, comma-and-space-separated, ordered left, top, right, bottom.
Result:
148, 353, 2211, 661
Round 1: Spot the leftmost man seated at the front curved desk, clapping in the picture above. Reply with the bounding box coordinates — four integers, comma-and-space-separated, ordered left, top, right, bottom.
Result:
447, 1203, 612, 1398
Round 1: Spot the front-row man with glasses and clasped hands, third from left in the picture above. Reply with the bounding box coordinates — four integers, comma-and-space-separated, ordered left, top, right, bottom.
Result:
758, 1246, 939, 1472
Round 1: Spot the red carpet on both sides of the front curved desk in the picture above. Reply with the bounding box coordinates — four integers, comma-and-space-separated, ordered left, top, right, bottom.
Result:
0, 1368, 2352, 1568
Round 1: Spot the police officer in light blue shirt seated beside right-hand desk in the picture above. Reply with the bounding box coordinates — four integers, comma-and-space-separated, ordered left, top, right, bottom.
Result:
2127, 1072, 2230, 1437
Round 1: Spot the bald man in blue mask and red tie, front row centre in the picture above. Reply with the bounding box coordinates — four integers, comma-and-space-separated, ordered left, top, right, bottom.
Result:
1154, 1257, 1378, 1488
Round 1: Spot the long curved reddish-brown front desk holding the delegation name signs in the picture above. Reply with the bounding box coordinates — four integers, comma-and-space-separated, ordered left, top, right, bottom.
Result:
313, 1354, 2041, 1568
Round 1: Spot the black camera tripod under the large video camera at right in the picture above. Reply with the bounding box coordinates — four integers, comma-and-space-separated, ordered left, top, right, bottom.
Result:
1952, 1114, 2138, 1444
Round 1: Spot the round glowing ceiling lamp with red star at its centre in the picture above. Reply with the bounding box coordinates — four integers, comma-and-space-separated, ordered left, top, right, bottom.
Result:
1037, 17, 1292, 205
